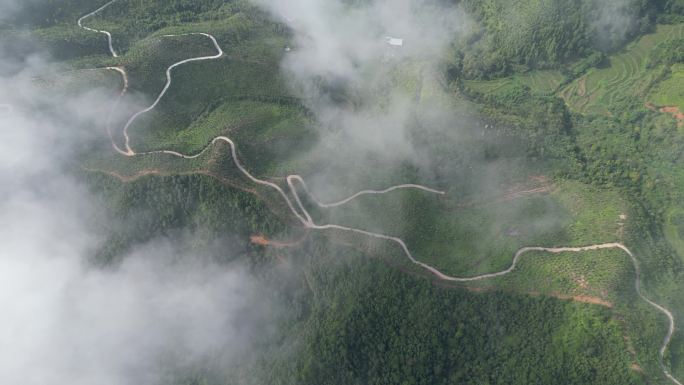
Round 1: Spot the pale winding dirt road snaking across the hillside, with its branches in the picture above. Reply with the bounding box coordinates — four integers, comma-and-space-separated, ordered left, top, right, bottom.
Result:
78, 0, 682, 385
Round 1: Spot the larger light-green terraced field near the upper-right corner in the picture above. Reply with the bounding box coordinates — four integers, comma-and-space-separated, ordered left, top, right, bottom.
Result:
559, 24, 684, 115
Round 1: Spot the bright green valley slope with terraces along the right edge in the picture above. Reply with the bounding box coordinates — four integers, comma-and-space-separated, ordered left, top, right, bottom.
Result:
460, 14, 684, 374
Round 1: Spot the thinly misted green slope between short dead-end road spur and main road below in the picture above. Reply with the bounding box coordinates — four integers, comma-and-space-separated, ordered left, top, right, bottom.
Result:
323, 176, 625, 276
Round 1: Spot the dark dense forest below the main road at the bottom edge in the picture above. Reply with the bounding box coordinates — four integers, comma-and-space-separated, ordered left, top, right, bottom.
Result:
267, 252, 640, 385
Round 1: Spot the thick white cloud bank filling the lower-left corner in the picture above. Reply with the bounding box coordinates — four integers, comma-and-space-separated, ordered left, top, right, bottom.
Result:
0, 42, 277, 385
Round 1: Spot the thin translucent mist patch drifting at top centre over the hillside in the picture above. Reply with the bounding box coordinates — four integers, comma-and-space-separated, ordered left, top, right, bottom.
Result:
254, 0, 470, 196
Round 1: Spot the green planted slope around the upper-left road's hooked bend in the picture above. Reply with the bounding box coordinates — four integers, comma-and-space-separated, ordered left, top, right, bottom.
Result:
96, 18, 301, 152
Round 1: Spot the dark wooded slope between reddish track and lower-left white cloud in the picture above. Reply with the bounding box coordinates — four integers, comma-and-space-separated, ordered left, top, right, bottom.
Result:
89, 175, 284, 264
